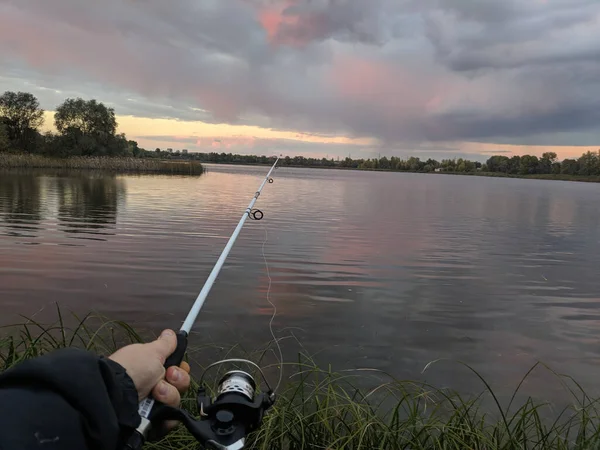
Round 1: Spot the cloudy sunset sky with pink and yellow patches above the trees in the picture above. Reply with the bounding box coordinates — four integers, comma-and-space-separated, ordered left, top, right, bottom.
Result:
0, 0, 600, 160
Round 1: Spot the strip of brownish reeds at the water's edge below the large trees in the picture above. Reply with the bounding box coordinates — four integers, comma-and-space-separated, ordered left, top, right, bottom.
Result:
0, 153, 204, 175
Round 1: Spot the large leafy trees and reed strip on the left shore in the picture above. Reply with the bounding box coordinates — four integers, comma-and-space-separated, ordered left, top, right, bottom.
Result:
0, 91, 202, 175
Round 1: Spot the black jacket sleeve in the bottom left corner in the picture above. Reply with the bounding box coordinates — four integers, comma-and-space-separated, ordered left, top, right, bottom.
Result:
0, 349, 140, 450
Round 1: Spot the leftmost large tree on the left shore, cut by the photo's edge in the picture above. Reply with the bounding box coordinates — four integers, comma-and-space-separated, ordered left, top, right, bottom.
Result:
0, 91, 44, 151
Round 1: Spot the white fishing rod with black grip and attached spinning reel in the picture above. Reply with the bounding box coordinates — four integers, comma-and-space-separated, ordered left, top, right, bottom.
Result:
126, 157, 279, 450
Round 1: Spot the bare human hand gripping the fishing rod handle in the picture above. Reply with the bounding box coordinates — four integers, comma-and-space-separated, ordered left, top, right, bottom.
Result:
109, 330, 190, 429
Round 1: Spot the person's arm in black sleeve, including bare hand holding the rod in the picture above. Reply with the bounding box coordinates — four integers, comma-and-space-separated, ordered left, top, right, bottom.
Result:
0, 332, 189, 450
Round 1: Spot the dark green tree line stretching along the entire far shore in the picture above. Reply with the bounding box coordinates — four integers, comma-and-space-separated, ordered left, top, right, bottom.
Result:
0, 91, 600, 176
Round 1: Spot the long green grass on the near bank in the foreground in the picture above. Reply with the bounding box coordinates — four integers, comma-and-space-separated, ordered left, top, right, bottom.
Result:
0, 310, 600, 450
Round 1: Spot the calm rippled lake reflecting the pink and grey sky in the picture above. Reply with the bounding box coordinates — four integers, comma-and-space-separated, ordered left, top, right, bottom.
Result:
0, 165, 600, 399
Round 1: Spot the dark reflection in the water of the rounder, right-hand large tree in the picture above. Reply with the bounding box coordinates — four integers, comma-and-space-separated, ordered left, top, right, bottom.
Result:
55, 175, 125, 240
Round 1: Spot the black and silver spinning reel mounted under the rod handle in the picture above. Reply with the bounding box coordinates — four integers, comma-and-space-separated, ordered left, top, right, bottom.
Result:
149, 360, 275, 450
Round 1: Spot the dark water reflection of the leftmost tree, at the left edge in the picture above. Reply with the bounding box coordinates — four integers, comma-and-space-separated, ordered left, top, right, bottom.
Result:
0, 172, 42, 238
